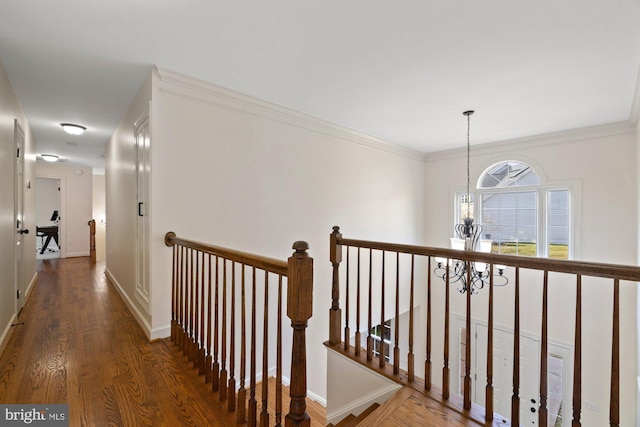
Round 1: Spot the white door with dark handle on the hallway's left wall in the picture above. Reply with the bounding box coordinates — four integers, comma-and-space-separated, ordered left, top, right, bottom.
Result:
13, 120, 29, 312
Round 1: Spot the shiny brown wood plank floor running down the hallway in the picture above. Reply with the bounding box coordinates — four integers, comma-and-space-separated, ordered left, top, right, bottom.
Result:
0, 258, 326, 426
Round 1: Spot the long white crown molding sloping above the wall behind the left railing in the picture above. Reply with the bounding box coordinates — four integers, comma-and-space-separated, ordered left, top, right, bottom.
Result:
155, 67, 424, 161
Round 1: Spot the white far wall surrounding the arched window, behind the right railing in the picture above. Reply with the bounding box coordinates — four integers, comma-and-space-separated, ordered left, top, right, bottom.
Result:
425, 125, 638, 425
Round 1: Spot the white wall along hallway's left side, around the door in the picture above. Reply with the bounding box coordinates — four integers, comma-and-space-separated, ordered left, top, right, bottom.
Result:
0, 58, 37, 351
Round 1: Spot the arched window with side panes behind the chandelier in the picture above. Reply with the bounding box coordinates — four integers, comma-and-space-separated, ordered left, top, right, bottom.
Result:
457, 160, 572, 259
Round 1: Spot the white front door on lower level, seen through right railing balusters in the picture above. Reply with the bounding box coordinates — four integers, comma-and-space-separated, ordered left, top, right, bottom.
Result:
474, 324, 540, 427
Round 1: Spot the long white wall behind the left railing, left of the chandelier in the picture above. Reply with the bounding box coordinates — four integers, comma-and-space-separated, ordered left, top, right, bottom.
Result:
141, 68, 424, 398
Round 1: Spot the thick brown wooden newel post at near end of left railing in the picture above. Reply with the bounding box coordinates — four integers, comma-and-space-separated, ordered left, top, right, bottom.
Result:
285, 242, 313, 427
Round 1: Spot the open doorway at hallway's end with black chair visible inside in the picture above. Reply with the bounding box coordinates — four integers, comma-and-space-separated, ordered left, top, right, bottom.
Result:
36, 178, 62, 259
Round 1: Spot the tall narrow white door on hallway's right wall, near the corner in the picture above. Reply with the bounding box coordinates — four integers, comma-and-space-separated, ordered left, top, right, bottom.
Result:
134, 114, 151, 311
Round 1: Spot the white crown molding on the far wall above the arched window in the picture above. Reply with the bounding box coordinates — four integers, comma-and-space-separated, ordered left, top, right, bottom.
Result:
424, 120, 636, 162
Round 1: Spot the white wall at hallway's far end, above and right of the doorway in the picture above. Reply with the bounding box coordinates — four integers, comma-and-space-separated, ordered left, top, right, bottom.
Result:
36, 161, 93, 258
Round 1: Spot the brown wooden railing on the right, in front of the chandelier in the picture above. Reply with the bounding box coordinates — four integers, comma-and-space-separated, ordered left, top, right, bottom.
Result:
325, 227, 640, 427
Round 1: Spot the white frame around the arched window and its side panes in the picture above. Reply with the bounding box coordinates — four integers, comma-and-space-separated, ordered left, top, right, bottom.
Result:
450, 157, 582, 260
